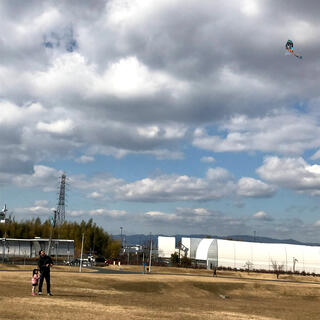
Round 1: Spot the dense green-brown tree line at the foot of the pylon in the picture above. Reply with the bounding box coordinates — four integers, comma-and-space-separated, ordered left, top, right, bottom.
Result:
0, 218, 121, 258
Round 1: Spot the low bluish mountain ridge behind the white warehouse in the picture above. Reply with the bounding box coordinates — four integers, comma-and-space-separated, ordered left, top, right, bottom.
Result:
112, 234, 320, 247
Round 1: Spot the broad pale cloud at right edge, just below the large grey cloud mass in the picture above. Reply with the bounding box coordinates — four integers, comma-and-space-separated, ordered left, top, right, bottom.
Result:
193, 111, 320, 155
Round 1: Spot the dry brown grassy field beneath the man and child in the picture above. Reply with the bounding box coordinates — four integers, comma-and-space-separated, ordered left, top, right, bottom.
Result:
0, 265, 320, 320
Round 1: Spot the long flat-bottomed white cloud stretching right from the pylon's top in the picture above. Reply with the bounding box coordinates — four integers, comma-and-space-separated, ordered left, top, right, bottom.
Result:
71, 167, 276, 202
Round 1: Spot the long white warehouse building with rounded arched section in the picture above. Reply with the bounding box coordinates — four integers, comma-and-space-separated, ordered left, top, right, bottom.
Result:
158, 236, 320, 274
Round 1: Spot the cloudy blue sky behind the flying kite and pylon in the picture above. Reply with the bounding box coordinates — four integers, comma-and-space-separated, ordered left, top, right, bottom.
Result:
0, 0, 320, 242
